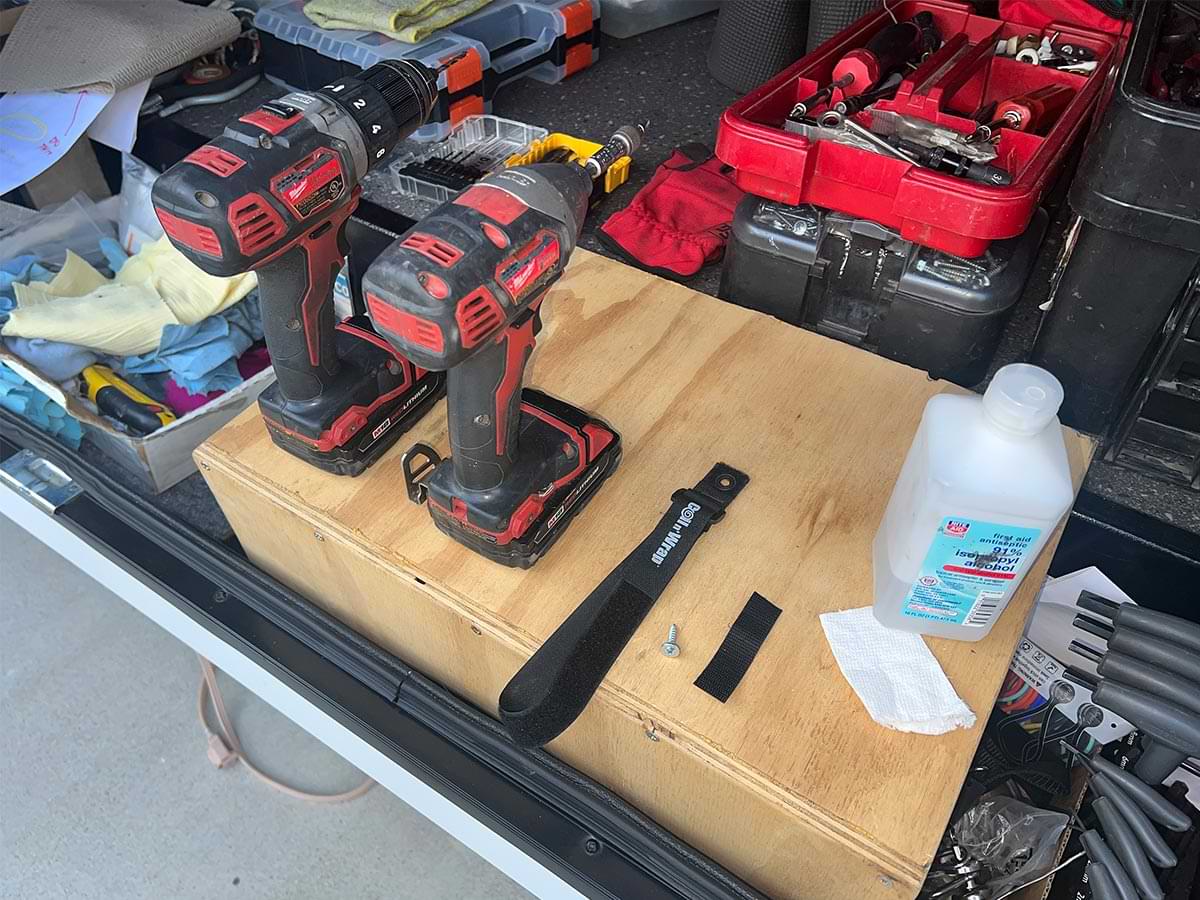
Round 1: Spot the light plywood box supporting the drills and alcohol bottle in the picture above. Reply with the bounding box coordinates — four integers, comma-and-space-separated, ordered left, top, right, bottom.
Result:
197, 251, 1092, 900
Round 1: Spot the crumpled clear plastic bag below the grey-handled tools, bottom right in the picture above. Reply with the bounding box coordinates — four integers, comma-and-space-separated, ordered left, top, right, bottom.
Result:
952, 797, 1069, 894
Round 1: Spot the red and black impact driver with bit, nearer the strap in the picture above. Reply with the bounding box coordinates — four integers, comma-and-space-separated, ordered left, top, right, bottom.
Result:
362, 126, 641, 568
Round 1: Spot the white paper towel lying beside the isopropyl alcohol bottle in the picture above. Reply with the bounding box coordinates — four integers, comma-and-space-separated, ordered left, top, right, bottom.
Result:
821, 606, 976, 734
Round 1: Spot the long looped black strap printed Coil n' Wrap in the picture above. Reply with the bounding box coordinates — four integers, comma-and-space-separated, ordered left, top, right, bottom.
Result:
499, 463, 750, 746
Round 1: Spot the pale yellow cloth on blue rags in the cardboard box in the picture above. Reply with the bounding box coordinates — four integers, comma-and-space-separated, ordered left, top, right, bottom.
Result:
2, 238, 258, 356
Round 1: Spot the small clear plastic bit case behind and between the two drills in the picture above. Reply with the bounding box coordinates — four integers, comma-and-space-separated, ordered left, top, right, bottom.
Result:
390, 115, 550, 203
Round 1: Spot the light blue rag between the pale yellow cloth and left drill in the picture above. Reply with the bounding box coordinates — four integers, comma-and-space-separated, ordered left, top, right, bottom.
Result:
119, 293, 263, 394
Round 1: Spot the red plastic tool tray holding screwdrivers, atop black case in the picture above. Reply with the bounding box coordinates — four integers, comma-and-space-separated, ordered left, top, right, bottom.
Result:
716, 0, 1120, 257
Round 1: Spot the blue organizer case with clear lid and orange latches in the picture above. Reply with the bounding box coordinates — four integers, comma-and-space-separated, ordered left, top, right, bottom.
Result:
254, 0, 600, 140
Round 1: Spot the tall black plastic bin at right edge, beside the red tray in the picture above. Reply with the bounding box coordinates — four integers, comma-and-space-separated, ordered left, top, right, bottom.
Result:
1033, 2, 1200, 437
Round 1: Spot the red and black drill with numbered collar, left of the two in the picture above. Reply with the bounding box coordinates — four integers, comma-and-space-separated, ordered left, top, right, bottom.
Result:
152, 60, 452, 475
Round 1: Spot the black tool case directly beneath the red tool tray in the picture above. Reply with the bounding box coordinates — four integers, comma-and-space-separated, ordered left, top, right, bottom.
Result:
719, 197, 1048, 386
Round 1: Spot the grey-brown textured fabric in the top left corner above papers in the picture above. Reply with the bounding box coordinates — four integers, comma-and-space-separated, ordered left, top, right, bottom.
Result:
0, 0, 241, 92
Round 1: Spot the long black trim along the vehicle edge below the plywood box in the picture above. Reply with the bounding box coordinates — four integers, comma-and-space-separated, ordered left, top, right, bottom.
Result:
0, 409, 766, 900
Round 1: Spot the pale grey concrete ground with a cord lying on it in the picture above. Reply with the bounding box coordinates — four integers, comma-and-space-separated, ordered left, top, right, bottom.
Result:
0, 517, 529, 900
